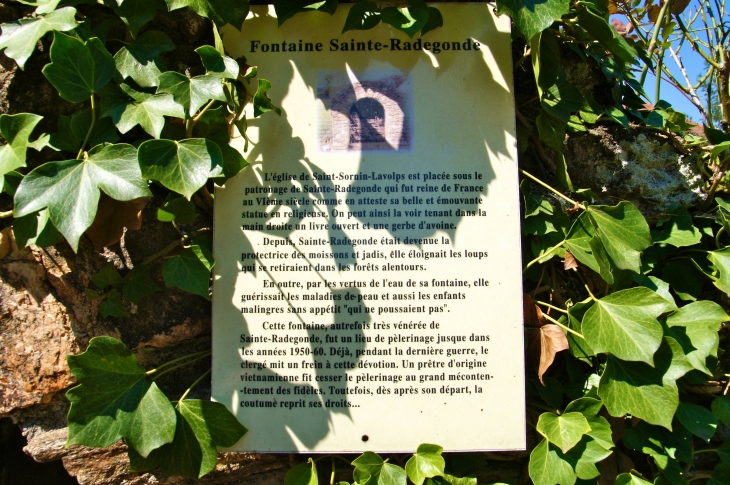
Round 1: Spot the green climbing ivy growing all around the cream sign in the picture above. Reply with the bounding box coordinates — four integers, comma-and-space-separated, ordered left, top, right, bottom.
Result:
0, 0, 730, 485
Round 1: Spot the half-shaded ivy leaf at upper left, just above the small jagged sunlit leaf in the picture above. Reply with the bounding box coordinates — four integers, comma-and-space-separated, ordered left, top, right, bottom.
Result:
114, 30, 175, 88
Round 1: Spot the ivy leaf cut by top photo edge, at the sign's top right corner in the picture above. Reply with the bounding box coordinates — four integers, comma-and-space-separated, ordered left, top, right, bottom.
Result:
497, 0, 570, 41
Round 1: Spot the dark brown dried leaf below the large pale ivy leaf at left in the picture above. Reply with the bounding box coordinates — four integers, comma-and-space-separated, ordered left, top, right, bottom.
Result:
86, 193, 150, 250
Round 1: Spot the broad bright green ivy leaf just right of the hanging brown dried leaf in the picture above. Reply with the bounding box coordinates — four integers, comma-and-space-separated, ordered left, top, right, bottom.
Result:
581, 287, 670, 364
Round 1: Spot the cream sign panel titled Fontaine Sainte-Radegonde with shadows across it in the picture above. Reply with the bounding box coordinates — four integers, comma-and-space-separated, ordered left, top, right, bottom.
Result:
212, 4, 525, 452
